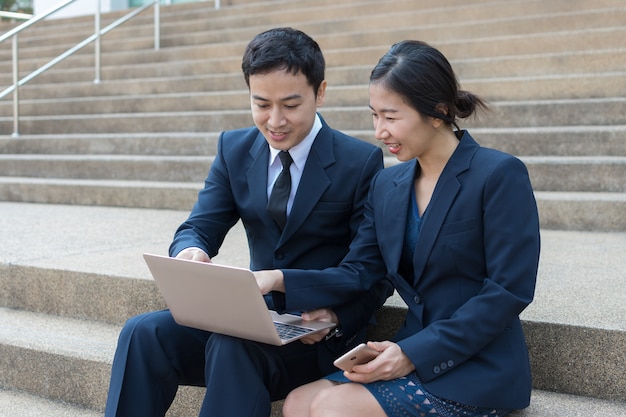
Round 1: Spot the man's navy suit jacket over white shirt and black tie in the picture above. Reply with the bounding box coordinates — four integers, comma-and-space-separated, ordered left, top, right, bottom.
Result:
170, 117, 391, 372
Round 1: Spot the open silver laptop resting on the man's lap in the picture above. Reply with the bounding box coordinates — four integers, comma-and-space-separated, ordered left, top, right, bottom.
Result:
143, 253, 335, 346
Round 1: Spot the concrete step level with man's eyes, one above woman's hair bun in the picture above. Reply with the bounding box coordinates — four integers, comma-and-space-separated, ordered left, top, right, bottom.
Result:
0, 71, 626, 117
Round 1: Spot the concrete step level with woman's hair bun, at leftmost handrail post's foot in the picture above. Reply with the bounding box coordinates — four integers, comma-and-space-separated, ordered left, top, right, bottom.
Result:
0, 97, 626, 135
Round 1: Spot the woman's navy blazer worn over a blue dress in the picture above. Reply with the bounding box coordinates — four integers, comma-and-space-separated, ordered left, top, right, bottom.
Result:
283, 132, 540, 409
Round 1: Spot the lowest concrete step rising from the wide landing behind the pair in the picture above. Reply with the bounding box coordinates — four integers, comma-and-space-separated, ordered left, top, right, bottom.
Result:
0, 177, 626, 232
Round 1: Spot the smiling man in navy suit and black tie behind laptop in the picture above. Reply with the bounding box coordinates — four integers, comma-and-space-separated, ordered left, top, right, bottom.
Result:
105, 28, 391, 417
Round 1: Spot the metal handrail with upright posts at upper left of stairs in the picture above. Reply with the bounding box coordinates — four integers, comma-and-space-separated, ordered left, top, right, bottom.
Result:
0, 0, 161, 137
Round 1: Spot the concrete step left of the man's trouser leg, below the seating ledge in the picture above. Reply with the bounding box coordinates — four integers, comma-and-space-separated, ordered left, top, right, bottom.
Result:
0, 308, 119, 409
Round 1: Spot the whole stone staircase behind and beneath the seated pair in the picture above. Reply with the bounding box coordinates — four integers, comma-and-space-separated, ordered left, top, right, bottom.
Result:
0, 0, 626, 417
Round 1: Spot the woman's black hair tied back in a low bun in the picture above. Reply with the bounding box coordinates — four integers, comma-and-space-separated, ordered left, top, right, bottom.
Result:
370, 40, 487, 129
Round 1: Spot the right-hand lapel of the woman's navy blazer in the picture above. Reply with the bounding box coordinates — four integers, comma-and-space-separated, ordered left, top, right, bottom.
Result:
413, 133, 478, 285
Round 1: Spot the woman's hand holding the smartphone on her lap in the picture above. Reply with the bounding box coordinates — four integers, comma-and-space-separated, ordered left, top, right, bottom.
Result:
344, 341, 415, 384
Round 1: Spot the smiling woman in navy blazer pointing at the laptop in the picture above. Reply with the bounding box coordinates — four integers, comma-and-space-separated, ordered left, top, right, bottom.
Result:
257, 41, 540, 417
